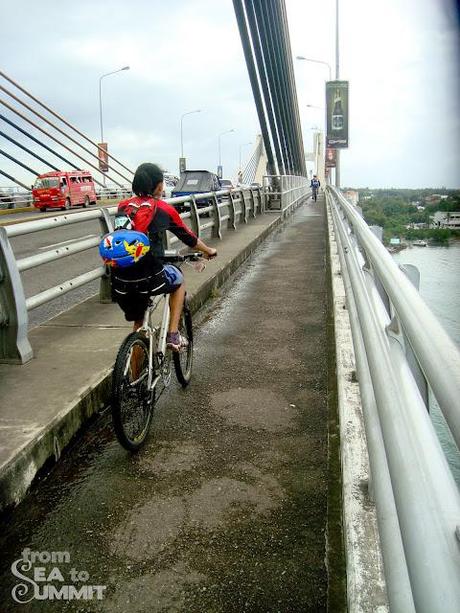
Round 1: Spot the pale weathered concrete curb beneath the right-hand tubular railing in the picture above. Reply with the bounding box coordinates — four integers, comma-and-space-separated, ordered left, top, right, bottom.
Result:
326, 200, 389, 613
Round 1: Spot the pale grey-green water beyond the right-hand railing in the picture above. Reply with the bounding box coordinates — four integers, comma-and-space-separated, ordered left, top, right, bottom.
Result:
393, 241, 460, 487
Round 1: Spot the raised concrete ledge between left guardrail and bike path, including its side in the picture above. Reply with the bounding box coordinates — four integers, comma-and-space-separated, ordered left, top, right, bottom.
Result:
0, 214, 288, 511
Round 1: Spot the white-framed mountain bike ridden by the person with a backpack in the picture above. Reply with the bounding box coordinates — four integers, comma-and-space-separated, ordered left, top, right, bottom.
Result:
112, 252, 205, 451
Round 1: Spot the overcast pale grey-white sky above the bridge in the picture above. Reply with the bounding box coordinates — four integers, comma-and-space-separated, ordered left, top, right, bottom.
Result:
0, 0, 460, 187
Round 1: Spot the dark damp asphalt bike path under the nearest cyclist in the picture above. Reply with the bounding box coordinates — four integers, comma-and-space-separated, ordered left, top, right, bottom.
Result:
0, 202, 338, 613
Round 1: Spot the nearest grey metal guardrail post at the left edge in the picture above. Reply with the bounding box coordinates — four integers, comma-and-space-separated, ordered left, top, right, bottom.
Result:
0, 227, 33, 364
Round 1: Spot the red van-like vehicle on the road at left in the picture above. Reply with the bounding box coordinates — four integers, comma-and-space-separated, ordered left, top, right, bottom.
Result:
32, 170, 96, 211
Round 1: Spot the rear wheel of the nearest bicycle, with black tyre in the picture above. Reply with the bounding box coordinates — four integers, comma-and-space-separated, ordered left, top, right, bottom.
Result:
112, 332, 155, 451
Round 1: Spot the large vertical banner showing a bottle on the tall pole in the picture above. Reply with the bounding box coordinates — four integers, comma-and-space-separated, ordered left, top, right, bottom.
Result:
326, 81, 348, 149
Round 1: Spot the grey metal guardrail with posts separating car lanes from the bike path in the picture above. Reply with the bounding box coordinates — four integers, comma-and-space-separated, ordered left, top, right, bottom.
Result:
0, 188, 276, 364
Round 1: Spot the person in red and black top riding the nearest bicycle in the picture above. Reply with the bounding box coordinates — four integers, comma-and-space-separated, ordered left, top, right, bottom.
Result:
108, 163, 217, 351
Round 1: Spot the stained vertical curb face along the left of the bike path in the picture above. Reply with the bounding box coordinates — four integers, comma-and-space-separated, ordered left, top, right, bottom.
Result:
0, 207, 297, 511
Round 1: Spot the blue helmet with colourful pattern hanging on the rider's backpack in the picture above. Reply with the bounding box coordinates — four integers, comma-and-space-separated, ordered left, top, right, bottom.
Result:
99, 230, 150, 268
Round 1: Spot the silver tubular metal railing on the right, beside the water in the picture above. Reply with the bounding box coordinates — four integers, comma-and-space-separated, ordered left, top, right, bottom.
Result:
327, 187, 460, 613
